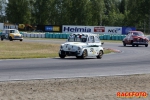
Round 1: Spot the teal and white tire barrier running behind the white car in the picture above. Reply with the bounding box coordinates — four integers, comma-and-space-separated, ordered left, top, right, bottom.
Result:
21, 32, 126, 40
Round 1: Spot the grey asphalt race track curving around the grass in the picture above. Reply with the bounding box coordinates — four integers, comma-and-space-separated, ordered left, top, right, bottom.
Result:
0, 39, 150, 81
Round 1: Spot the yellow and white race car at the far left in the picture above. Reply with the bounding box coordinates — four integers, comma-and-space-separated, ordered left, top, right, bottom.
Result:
1, 29, 23, 41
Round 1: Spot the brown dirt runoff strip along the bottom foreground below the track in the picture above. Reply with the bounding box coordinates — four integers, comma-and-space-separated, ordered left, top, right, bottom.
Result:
0, 74, 150, 100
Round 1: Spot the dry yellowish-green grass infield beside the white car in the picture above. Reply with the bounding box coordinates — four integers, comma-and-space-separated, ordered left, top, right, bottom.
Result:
0, 41, 113, 59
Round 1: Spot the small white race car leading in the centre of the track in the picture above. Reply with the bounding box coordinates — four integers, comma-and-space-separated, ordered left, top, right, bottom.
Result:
59, 33, 104, 59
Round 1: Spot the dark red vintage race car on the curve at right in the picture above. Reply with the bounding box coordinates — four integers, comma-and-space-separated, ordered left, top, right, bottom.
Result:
122, 31, 149, 47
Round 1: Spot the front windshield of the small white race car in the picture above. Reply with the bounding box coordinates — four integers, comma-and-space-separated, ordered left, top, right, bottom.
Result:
68, 35, 87, 42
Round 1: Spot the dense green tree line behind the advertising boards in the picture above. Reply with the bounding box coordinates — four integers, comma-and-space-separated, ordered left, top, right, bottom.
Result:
0, 0, 150, 33
